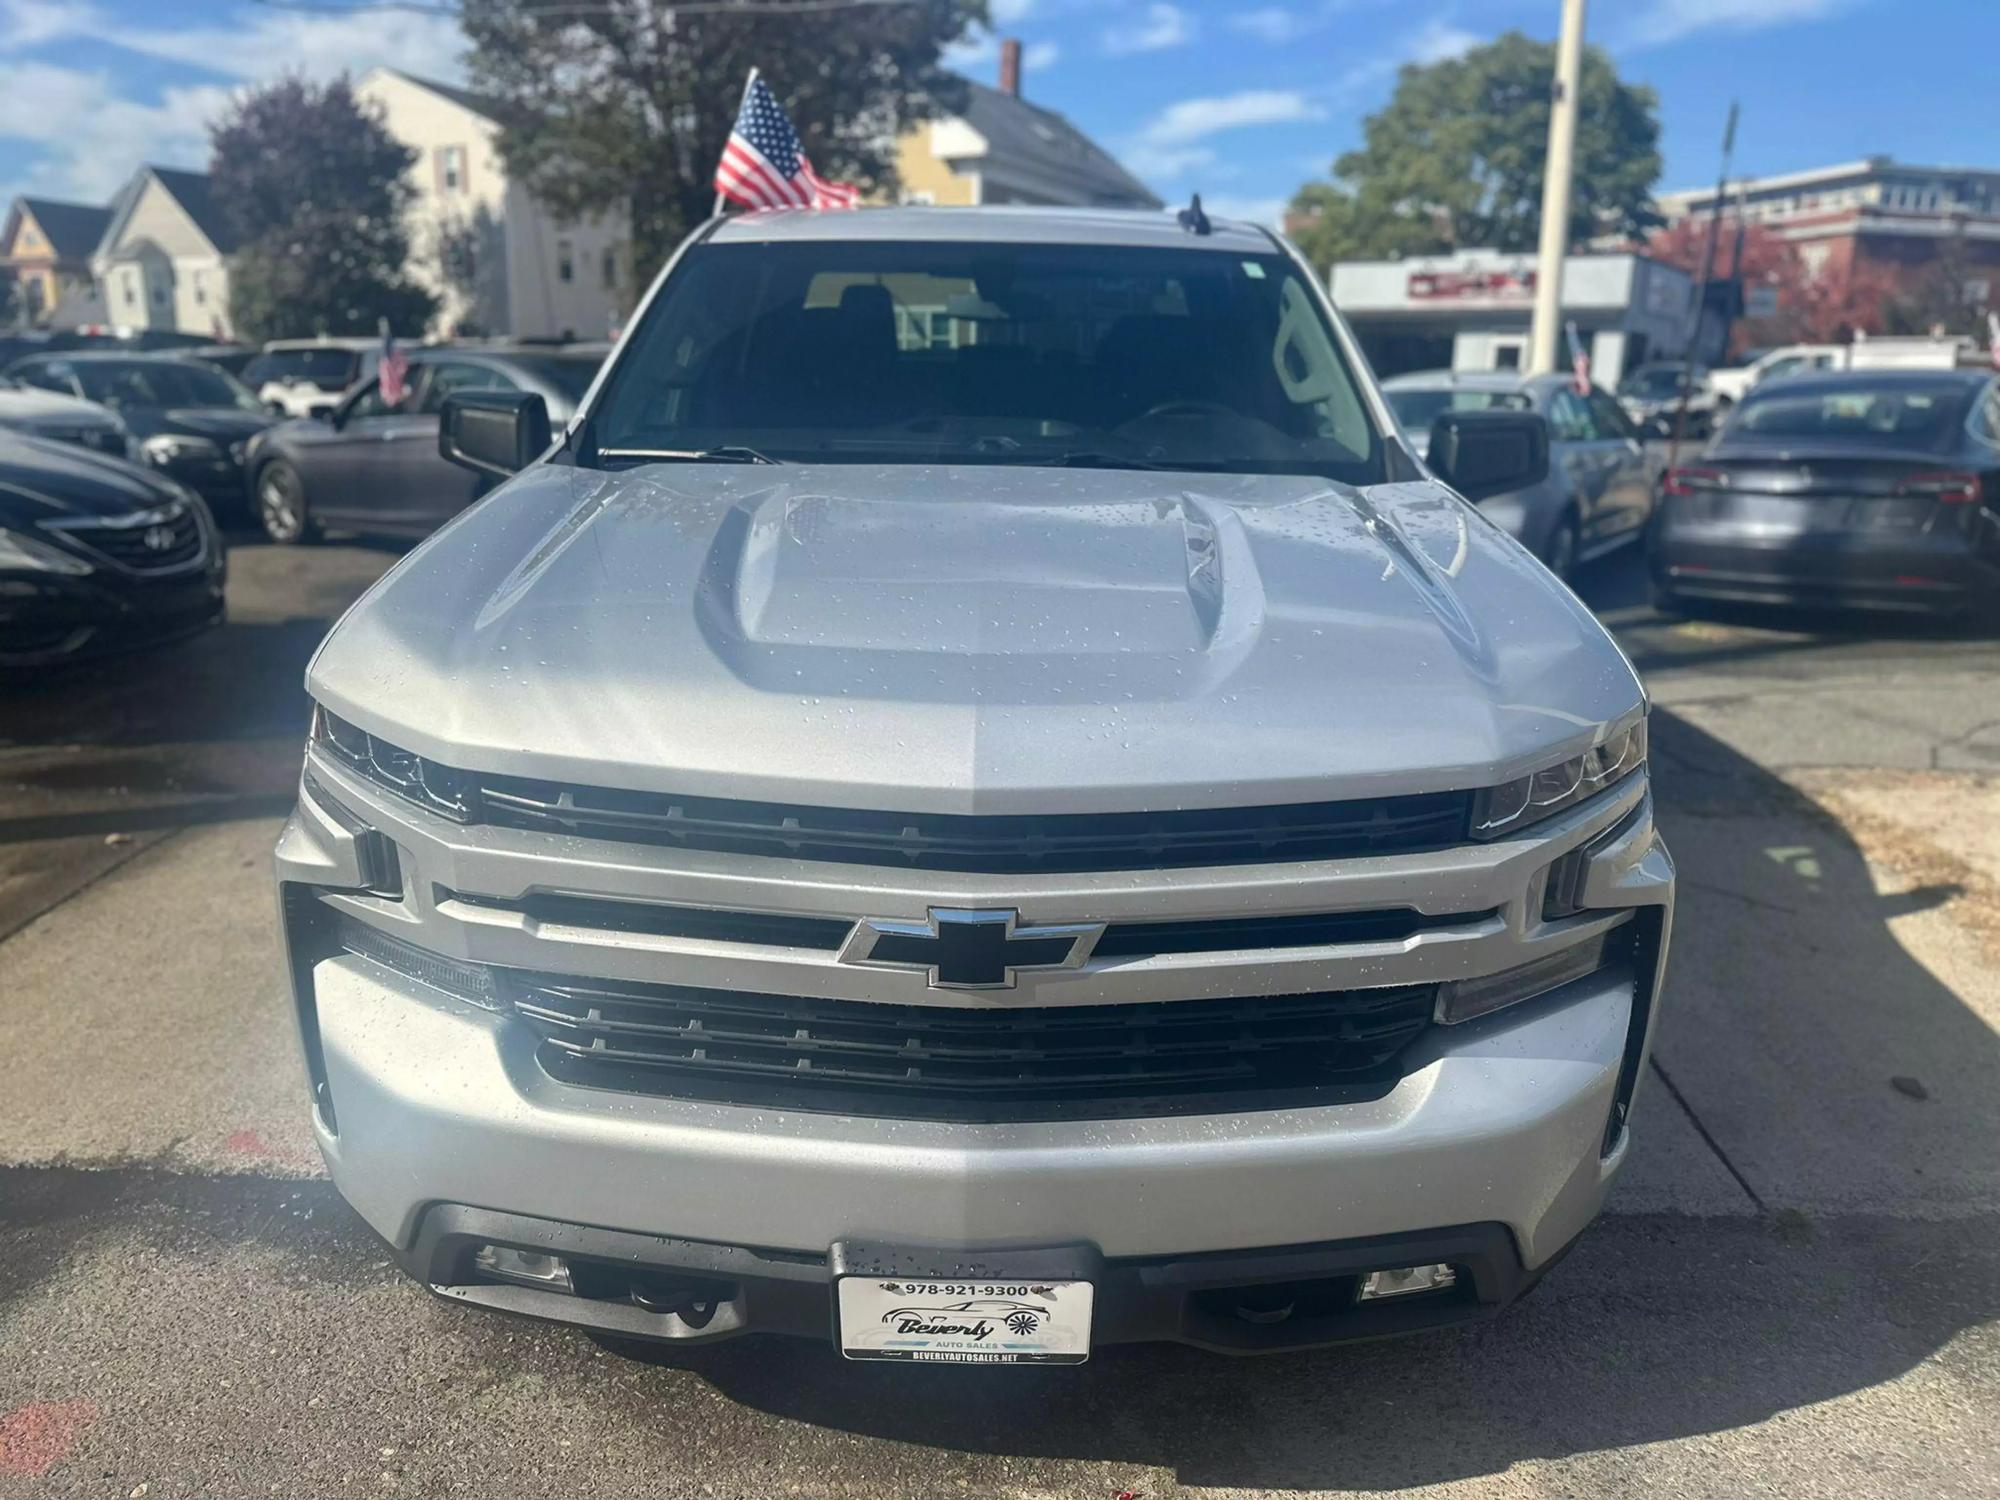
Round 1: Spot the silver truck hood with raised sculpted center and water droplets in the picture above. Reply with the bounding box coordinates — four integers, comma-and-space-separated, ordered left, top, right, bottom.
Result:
308, 464, 1640, 812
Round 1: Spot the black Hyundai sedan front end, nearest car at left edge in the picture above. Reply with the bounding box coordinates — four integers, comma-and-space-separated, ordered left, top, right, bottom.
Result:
0, 432, 224, 680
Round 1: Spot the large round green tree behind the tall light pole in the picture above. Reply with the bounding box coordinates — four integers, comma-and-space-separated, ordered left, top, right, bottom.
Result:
1288, 32, 1660, 266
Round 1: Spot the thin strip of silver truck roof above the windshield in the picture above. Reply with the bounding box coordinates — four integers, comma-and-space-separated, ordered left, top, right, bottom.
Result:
710, 204, 1274, 254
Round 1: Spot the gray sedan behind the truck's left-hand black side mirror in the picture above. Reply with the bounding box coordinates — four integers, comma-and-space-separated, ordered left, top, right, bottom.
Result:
246, 344, 606, 542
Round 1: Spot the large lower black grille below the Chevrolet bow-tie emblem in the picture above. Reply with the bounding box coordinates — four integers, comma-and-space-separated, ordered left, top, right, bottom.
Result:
506, 976, 1436, 1120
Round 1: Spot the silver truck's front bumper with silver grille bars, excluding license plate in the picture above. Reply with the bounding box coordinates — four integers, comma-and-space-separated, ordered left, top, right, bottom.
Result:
278, 758, 1672, 1348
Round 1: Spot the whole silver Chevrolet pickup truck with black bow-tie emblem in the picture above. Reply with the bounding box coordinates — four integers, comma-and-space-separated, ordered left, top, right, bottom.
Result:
278, 208, 1674, 1364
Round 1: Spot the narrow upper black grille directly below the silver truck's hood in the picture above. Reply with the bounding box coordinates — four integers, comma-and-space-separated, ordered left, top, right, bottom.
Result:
478, 778, 1472, 874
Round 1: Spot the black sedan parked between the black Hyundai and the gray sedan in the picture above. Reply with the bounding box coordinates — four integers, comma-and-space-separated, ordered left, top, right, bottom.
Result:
6, 350, 276, 514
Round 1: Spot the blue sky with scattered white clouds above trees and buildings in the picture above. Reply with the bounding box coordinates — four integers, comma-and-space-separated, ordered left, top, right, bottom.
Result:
0, 0, 2000, 218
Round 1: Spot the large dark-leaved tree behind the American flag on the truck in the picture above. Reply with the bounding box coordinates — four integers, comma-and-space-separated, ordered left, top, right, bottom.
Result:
460, 0, 986, 282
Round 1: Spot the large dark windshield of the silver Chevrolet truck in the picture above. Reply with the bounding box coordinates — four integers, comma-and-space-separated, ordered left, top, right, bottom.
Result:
586, 242, 1382, 484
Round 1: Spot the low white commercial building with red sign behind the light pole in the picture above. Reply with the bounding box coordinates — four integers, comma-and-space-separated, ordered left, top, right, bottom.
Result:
1332, 250, 1718, 386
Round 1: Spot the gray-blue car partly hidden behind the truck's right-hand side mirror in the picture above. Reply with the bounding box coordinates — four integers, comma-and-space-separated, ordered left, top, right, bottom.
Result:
1382, 370, 1654, 578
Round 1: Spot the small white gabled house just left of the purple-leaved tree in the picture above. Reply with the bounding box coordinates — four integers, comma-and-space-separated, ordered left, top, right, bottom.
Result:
90, 166, 236, 338
